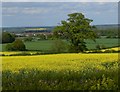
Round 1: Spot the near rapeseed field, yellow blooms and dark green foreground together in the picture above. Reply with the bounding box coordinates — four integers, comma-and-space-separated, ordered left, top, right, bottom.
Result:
2, 53, 119, 90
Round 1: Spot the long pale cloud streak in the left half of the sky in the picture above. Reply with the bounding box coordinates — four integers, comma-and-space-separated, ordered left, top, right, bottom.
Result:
2, 7, 53, 16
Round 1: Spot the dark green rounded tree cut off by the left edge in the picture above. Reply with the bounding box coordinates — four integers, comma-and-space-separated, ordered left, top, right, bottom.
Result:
2, 32, 15, 43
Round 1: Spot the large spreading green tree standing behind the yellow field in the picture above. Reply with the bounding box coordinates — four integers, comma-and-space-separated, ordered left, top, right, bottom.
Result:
53, 13, 96, 52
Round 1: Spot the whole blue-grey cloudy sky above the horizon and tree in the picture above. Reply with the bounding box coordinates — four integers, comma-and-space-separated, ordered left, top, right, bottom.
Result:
2, 0, 118, 27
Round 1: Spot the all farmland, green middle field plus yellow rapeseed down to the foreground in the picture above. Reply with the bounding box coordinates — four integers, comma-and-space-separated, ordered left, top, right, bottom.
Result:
0, 26, 119, 90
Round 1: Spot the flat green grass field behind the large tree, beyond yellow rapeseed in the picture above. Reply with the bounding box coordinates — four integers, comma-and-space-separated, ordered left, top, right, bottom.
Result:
2, 39, 118, 51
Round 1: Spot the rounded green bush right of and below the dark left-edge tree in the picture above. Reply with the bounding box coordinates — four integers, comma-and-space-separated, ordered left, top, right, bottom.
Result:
6, 39, 26, 51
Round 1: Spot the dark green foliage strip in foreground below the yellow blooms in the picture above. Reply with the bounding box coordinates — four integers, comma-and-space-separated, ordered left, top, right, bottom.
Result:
2, 61, 118, 90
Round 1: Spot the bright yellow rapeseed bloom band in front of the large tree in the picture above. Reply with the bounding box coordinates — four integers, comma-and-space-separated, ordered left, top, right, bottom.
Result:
0, 53, 118, 72
